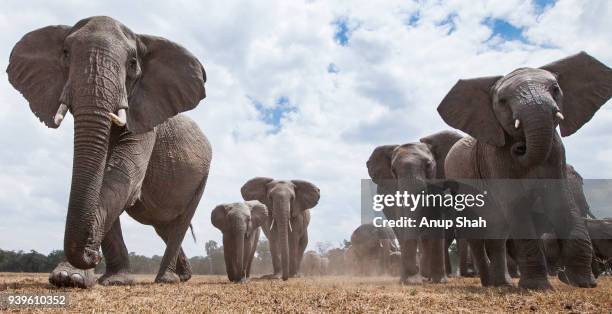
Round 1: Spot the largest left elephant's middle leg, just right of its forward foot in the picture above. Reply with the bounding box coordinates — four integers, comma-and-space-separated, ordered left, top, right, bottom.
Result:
98, 218, 134, 286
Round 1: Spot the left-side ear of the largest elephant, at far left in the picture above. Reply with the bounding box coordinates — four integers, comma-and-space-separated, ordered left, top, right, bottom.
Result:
6, 25, 71, 128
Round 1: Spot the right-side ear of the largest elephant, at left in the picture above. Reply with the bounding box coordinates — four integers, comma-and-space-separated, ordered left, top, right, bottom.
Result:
127, 35, 206, 133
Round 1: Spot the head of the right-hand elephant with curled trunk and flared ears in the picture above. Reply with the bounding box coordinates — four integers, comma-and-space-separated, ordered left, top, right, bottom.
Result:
438, 52, 612, 168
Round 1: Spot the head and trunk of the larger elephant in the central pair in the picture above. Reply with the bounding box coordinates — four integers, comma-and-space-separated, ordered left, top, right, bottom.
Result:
240, 177, 321, 280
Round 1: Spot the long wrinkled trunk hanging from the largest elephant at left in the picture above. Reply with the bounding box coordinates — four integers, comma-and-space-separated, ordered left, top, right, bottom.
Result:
64, 110, 111, 269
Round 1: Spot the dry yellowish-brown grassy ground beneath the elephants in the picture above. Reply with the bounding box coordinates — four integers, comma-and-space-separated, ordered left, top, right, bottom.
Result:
0, 273, 612, 313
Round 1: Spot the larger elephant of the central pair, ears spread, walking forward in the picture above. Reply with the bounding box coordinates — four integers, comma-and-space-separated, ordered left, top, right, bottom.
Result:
240, 177, 321, 280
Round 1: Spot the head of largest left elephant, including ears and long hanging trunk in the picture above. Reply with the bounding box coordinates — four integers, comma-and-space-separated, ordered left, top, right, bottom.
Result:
7, 16, 206, 269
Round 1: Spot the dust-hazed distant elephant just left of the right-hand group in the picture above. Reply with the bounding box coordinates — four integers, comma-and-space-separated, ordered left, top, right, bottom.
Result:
351, 223, 399, 275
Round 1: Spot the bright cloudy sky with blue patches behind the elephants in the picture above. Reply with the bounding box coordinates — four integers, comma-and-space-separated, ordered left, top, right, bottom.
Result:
0, 0, 612, 256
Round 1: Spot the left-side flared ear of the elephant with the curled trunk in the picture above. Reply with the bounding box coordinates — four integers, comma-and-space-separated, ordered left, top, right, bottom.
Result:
438, 76, 505, 147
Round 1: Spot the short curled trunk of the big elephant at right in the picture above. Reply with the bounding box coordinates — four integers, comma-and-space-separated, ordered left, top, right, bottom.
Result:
511, 104, 554, 168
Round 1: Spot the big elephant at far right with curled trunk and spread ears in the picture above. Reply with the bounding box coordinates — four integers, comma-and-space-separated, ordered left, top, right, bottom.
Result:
438, 53, 612, 289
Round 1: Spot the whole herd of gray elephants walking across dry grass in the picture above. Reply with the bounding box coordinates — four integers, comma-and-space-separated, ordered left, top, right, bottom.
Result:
7, 16, 612, 289
